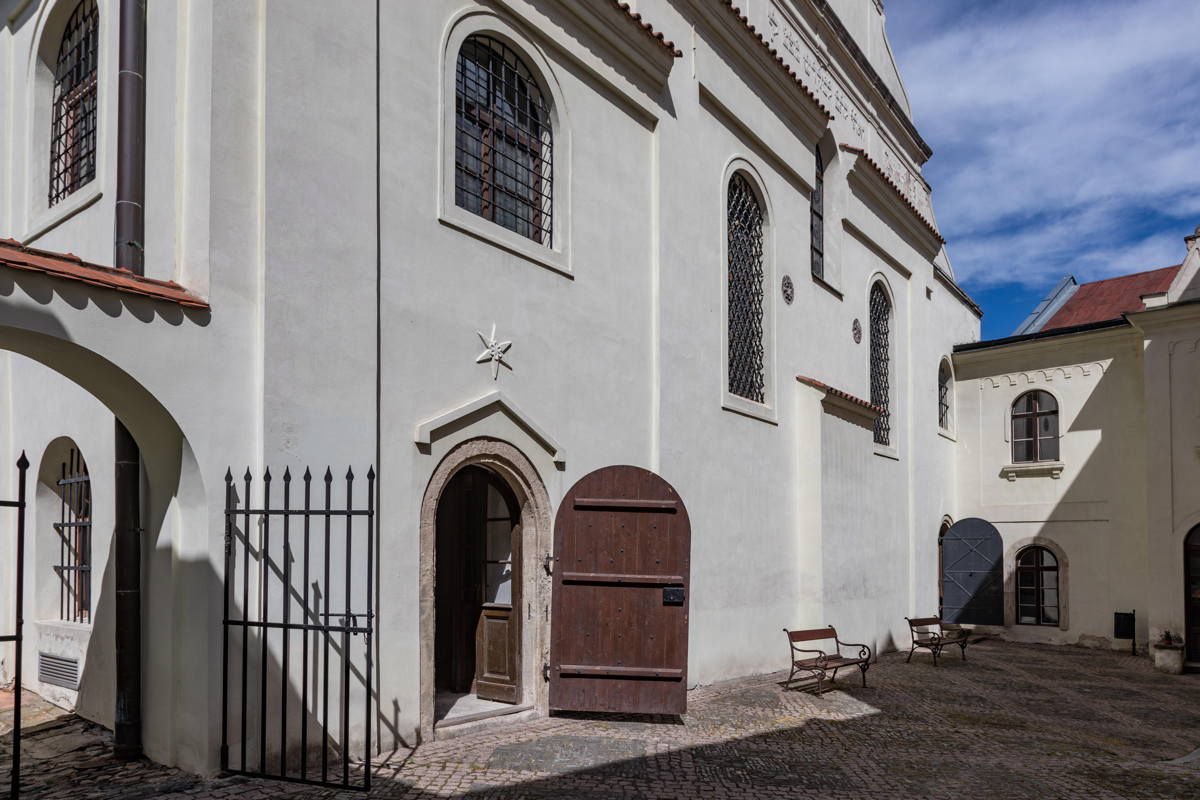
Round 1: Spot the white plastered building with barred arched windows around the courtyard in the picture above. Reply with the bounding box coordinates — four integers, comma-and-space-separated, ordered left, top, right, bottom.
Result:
0, 0, 1200, 786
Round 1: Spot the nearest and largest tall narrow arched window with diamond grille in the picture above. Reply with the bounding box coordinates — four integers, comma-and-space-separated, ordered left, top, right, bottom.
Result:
726, 174, 767, 403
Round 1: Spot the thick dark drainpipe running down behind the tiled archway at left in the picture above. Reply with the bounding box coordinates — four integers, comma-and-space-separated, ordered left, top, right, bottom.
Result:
113, 0, 146, 759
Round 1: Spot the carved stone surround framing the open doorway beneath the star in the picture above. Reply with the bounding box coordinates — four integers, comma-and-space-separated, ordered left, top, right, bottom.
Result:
420, 437, 553, 741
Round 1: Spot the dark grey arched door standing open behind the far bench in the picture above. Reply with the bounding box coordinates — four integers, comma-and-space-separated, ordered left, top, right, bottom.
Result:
941, 517, 1004, 625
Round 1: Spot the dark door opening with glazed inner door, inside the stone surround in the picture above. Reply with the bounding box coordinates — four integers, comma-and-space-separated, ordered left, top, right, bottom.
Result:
434, 467, 521, 722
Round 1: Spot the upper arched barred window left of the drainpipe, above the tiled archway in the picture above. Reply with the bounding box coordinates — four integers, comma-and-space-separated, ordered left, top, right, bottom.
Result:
49, 0, 100, 205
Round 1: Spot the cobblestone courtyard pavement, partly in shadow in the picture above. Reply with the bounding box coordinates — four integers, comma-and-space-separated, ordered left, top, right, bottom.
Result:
0, 642, 1200, 800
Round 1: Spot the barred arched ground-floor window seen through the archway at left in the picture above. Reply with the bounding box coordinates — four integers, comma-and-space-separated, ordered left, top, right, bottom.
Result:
54, 449, 91, 622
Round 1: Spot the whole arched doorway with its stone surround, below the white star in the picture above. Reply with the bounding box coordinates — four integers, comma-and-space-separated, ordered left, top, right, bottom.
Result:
420, 438, 552, 740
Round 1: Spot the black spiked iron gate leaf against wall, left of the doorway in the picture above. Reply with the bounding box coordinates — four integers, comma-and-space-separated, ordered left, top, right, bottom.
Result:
221, 468, 376, 789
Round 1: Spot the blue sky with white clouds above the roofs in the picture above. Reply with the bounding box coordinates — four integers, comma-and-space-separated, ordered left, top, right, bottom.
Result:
884, 0, 1200, 338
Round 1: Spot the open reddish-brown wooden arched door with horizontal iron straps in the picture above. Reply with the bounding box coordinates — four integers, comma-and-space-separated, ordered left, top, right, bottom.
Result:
550, 467, 691, 714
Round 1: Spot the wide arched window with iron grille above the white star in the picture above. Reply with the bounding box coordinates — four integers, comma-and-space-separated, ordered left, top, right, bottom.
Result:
455, 35, 553, 246
